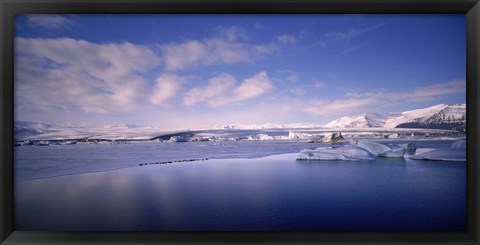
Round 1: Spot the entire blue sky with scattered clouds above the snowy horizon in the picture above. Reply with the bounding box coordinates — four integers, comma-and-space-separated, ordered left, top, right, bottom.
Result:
14, 14, 466, 128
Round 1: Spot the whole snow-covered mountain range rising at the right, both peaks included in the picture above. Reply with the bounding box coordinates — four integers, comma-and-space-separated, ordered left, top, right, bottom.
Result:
325, 104, 466, 131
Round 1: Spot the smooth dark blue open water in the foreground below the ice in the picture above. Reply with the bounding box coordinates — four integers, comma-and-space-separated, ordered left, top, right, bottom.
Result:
15, 154, 466, 231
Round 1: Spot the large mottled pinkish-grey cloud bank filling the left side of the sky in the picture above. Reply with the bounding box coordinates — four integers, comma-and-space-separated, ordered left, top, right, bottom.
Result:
15, 38, 160, 113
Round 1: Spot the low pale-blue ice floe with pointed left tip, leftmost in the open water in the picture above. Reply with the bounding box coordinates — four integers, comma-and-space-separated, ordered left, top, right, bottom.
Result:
297, 145, 376, 161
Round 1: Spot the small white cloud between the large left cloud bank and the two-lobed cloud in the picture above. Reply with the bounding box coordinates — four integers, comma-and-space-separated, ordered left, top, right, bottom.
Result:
150, 74, 187, 105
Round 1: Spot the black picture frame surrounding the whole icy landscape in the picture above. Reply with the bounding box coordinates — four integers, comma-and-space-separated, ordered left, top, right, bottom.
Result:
0, 0, 480, 244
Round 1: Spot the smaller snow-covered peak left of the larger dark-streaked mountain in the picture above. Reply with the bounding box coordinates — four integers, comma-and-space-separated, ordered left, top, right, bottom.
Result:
324, 112, 387, 128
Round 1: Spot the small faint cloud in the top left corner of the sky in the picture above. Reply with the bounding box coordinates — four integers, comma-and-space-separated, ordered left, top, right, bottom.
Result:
26, 14, 75, 30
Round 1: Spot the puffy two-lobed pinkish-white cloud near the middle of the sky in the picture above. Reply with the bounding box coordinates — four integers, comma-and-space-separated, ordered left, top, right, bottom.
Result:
183, 71, 274, 107
